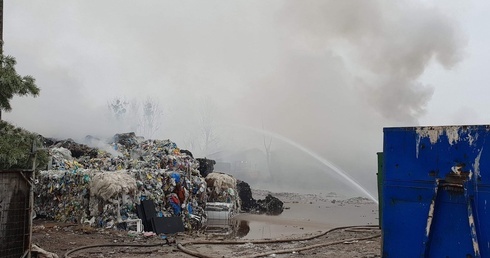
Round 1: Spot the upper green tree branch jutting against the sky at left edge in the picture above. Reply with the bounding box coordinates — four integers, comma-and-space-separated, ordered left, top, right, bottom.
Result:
0, 55, 40, 111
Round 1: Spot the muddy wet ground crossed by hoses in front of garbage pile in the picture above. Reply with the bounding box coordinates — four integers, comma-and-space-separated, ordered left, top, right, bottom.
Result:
33, 191, 380, 258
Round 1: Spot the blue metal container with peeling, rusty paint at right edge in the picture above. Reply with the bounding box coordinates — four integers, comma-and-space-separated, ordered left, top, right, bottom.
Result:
382, 125, 490, 258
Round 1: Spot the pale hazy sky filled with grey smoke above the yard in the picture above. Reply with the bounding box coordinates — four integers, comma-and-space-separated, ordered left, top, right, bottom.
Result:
4, 0, 490, 198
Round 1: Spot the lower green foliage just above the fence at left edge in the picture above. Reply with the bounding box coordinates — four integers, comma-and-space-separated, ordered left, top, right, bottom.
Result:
0, 121, 48, 169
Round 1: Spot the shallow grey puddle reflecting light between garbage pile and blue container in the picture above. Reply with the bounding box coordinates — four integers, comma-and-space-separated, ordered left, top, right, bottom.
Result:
201, 203, 377, 239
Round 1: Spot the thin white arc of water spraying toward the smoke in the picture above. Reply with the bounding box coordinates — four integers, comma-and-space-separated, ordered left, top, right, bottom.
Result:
228, 124, 378, 204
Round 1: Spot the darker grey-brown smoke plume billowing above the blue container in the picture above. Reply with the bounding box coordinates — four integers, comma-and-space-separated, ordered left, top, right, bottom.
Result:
285, 1, 461, 123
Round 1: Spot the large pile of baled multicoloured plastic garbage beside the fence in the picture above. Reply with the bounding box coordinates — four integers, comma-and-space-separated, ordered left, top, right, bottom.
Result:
35, 133, 207, 228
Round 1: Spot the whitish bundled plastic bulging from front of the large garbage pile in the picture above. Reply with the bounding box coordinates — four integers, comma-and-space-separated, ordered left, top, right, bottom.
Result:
90, 171, 138, 201
